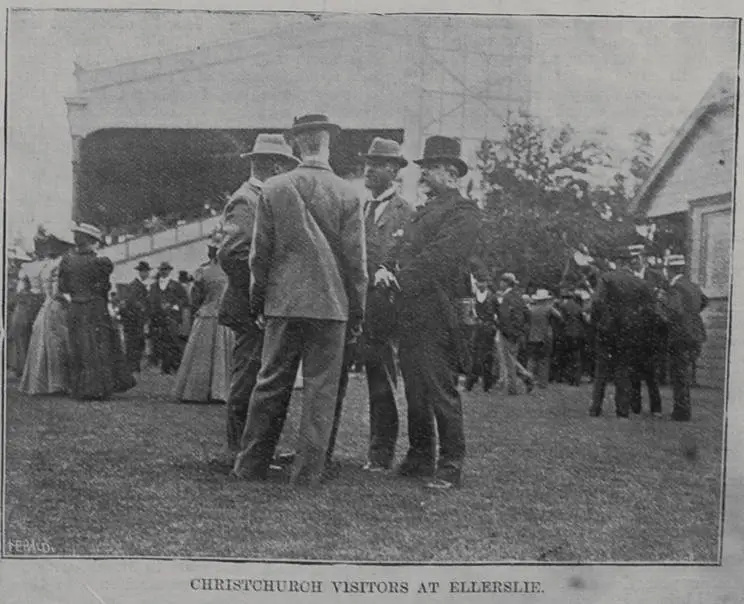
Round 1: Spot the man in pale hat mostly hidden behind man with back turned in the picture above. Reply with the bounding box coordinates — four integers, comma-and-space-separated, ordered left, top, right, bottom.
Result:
217, 134, 300, 467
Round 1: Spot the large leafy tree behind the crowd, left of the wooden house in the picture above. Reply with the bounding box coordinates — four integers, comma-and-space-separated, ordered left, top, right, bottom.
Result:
478, 112, 641, 288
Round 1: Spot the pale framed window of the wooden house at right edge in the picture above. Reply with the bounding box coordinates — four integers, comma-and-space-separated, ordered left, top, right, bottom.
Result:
700, 209, 731, 297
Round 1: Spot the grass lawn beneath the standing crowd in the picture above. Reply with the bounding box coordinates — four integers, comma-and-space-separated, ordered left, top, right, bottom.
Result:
5, 372, 723, 562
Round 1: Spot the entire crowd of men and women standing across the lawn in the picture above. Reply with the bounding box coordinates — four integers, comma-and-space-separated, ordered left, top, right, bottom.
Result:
8, 114, 706, 489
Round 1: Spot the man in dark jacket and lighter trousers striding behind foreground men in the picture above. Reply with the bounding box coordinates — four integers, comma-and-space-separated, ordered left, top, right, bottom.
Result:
499, 273, 532, 395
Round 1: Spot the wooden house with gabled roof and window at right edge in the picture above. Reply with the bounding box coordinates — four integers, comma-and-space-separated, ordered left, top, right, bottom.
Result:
633, 73, 737, 388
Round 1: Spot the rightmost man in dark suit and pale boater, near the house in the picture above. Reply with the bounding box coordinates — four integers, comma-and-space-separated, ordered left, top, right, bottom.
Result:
663, 255, 708, 422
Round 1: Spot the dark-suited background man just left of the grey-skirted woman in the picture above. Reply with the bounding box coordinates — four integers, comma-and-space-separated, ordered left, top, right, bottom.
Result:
149, 260, 189, 374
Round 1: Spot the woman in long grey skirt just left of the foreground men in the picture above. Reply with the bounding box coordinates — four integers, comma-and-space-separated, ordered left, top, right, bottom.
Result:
174, 238, 235, 402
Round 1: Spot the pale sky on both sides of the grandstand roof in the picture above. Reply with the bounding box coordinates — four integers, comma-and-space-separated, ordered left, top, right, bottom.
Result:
6, 11, 738, 245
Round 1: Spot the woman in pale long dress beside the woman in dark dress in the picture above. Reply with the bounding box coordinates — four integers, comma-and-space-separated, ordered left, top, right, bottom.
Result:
20, 233, 74, 394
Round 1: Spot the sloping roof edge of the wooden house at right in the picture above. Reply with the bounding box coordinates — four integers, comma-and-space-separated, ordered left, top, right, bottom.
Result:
630, 72, 737, 214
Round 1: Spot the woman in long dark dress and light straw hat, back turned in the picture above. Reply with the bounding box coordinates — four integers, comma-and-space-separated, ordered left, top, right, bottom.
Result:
59, 224, 136, 400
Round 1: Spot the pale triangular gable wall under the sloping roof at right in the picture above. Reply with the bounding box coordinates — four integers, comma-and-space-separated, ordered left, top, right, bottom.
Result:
647, 106, 736, 218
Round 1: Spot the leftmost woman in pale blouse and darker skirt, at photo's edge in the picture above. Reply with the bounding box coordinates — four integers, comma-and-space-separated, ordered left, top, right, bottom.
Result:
7, 235, 48, 377
